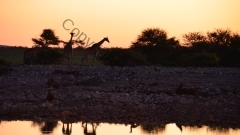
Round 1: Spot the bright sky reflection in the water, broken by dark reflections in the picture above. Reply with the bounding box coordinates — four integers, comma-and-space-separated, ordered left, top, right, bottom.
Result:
0, 121, 240, 135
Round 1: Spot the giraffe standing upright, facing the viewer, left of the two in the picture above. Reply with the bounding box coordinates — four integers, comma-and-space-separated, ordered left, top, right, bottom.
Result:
63, 33, 75, 64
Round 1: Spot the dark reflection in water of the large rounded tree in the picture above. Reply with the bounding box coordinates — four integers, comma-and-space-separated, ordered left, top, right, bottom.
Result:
141, 124, 166, 134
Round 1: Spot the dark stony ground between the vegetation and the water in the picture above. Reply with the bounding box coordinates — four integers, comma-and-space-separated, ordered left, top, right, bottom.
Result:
0, 66, 240, 128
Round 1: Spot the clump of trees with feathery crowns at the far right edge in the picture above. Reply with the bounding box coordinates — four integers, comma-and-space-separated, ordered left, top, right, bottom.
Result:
183, 29, 240, 66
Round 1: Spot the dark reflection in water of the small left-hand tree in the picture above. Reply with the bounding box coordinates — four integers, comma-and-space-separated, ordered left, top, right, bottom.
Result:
32, 121, 58, 134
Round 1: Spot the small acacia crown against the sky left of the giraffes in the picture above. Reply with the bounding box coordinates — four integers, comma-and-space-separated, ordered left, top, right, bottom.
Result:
32, 29, 61, 48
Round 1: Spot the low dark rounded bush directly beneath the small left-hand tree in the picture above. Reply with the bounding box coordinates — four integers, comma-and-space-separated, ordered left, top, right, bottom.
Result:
36, 48, 63, 64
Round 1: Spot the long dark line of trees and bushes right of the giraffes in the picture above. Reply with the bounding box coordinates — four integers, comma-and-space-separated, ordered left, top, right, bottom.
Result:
99, 28, 240, 67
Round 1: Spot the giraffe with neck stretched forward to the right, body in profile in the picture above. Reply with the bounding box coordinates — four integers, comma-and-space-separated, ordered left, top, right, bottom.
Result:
81, 37, 110, 65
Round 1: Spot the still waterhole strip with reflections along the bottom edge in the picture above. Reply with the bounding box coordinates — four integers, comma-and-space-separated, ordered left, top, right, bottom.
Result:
0, 121, 240, 135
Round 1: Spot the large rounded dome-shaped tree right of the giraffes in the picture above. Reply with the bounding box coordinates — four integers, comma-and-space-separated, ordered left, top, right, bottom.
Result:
130, 28, 179, 64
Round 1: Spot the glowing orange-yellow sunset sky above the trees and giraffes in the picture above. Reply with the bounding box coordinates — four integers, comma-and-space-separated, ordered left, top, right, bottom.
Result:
0, 0, 240, 47
